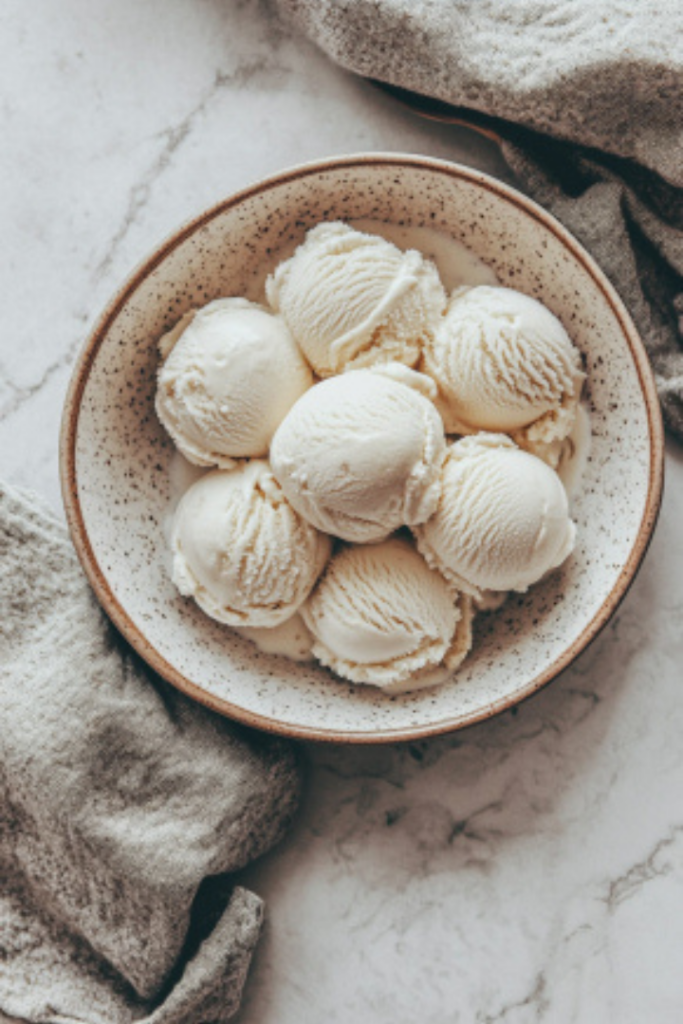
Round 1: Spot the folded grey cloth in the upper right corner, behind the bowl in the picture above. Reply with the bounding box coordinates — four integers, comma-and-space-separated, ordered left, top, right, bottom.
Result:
275, 0, 683, 439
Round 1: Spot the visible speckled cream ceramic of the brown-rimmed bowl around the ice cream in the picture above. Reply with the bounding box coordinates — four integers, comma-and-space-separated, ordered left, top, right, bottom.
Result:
61, 154, 663, 742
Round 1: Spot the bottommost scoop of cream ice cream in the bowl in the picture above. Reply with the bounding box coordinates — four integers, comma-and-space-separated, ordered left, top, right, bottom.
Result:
301, 537, 472, 692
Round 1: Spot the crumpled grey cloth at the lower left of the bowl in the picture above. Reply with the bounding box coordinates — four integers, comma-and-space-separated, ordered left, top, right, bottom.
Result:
0, 484, 300, 1024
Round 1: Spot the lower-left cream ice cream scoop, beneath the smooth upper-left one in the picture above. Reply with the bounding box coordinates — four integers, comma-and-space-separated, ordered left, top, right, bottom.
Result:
171, 459, 331, 627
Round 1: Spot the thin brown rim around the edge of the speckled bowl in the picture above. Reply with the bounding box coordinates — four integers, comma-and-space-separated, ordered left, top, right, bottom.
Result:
59, 154, 664, 743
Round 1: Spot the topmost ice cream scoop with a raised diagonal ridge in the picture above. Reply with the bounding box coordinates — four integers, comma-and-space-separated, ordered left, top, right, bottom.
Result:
266, 221, 446, 377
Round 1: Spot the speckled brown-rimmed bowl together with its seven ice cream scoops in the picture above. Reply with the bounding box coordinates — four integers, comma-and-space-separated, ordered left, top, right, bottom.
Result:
61, 155, 663, 741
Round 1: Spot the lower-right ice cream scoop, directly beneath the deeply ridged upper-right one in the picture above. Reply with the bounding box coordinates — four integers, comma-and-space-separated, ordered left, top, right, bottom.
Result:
415, 433, 575, 599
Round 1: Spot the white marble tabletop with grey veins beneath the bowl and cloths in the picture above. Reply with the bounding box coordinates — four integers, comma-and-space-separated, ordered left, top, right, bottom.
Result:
0, 0, 683, 1024
